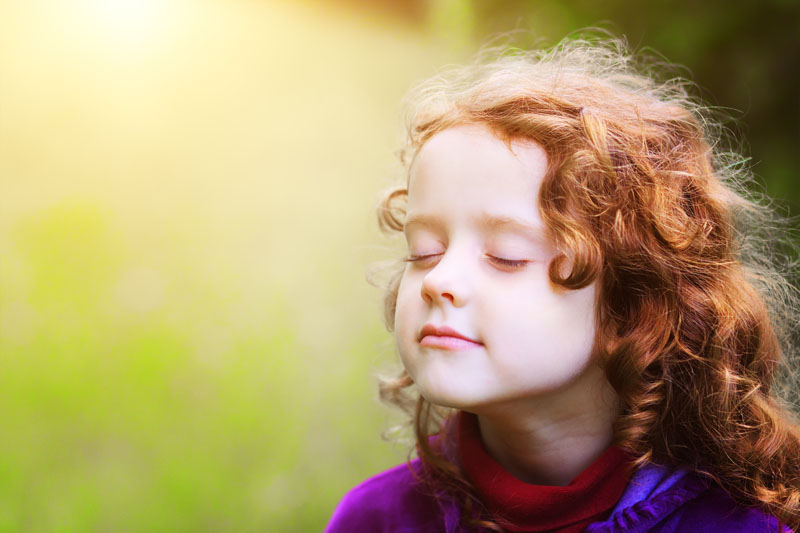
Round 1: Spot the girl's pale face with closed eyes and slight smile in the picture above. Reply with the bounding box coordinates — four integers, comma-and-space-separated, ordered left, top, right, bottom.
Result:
395, 125, 595, 412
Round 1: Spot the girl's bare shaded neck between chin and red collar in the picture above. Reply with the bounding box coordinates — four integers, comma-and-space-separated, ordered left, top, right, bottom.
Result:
475, 367, 619, 486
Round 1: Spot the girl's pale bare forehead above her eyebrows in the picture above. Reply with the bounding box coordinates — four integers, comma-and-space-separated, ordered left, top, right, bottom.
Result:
408, 125, 547, 226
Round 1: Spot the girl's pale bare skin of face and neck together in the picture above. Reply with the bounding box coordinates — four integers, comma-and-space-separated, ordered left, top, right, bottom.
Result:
395, 125, 618, 485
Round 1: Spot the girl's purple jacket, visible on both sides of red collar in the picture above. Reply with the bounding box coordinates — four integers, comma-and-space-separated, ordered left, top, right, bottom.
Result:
326, 459, 791, 533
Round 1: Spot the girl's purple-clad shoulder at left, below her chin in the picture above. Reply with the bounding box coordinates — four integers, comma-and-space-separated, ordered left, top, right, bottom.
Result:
325, 459, 442, 533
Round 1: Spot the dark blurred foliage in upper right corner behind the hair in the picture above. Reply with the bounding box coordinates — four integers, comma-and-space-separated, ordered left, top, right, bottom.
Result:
465, 0, 800, 215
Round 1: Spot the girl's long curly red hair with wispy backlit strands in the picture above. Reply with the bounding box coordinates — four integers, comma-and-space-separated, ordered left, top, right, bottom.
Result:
378, 38, 800, 529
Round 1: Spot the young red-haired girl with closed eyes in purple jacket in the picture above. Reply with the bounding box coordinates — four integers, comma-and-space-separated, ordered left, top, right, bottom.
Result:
328, 35, 800, 532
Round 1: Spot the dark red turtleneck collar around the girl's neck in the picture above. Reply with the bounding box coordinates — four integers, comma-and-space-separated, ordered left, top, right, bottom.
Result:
458, 412, 632, 532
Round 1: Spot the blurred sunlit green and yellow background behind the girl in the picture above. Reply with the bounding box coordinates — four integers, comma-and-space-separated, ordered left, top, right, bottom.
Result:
0, 0, 800, 531
